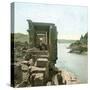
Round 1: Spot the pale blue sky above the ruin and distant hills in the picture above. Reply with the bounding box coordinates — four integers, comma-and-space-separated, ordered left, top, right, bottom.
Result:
15, 3, 88, 40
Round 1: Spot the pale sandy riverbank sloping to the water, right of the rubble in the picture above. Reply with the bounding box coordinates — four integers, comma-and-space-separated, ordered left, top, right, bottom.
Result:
47, 68, 80, 86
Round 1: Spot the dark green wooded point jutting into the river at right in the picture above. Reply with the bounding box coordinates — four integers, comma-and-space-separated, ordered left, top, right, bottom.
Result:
69, 33, 88, 54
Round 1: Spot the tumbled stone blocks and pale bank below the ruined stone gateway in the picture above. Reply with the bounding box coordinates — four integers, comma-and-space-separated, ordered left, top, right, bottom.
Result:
14, 42, 79, 87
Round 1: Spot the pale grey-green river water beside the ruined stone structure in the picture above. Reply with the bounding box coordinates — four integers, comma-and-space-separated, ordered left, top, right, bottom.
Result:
56, 43, 88, 83
